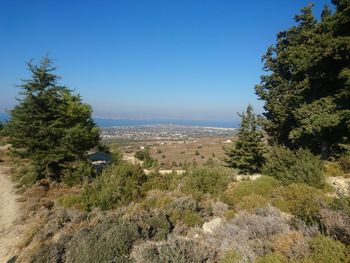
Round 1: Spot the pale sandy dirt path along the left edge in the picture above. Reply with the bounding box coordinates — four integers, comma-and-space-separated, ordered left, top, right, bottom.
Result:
0, 166, 20, 262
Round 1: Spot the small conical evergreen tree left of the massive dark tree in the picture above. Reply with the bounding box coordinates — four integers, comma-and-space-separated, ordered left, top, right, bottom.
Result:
224, 105, 265, 174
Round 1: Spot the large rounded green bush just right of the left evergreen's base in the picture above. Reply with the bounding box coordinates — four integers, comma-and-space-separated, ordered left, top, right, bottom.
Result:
82, 163, 146, 210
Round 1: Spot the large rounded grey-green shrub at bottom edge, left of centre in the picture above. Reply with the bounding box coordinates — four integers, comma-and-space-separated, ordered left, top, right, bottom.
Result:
66, 219, 139, 263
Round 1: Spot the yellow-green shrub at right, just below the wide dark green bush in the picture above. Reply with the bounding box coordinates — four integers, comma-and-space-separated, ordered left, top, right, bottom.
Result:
272, 184, 329, 224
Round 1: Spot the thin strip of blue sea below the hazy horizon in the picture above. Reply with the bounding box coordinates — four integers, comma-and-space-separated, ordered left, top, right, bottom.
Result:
0, 113, 238, 128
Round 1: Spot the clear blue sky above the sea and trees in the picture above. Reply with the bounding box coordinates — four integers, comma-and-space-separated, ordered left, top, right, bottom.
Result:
0, 0, 330, 120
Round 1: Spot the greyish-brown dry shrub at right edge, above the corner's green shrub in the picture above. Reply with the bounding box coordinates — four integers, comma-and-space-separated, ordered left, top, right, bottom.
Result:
320, 209, 350, 245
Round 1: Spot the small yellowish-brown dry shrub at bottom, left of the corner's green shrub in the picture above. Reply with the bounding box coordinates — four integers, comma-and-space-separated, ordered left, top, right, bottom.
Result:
272, 231, 309, 260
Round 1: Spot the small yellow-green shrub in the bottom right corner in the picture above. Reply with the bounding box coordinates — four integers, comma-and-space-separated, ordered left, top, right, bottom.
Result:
310, 235, 346, 263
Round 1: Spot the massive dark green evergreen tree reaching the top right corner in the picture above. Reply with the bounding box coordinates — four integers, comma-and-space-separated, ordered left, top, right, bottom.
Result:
256, 0, 350, 159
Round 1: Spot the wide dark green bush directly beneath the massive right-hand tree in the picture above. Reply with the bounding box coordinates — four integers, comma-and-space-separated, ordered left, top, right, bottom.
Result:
262, 147, 324, 188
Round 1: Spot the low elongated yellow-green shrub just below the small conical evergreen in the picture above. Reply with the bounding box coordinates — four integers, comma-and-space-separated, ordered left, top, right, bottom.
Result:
223, 176, 279, 207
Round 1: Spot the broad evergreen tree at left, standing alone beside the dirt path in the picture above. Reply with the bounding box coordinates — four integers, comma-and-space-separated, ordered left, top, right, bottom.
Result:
6, 57, 100, 178
